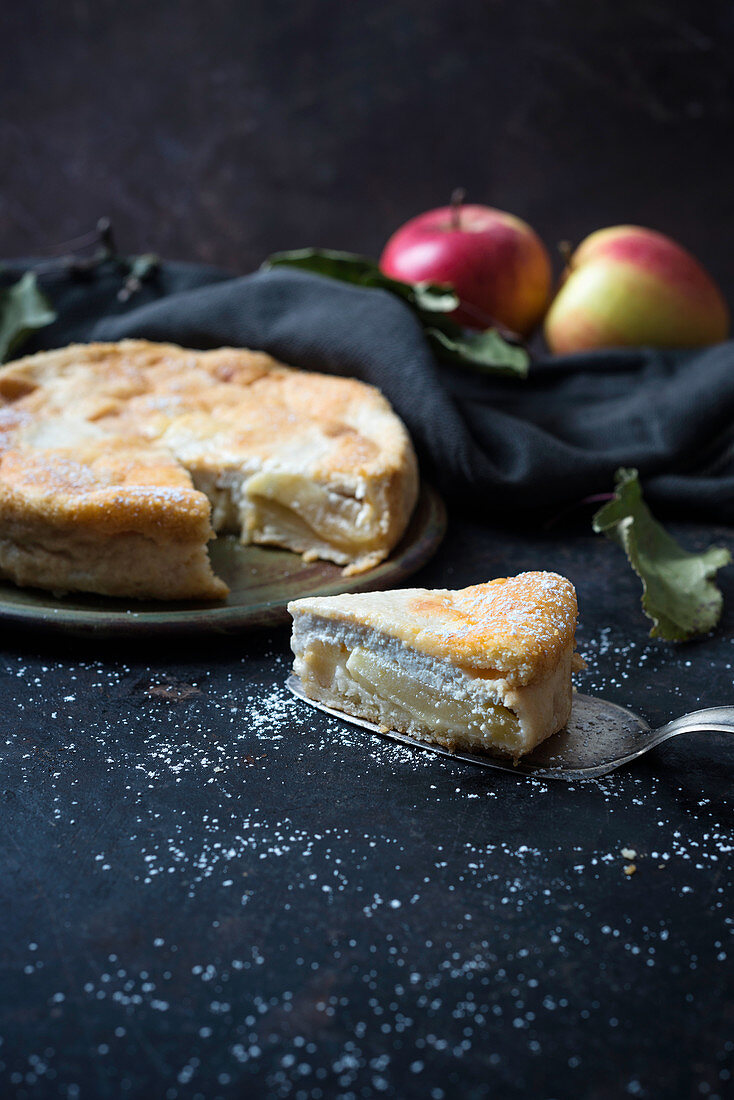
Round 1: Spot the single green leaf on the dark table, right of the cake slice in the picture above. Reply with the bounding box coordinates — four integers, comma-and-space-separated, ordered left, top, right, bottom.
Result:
592, 469, 732, 641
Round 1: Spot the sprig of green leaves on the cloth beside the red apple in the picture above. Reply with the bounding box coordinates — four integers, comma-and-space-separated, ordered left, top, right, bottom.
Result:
263, 249, 530, 378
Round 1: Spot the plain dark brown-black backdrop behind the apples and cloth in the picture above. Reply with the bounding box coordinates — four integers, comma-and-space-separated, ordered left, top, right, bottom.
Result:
0, 0, 734, 299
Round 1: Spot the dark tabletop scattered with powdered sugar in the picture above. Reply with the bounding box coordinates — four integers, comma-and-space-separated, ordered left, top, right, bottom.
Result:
0, 517, 734, 1100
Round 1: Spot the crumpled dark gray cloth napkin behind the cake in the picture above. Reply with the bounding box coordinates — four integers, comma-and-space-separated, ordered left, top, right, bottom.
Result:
7, 255, 734, 523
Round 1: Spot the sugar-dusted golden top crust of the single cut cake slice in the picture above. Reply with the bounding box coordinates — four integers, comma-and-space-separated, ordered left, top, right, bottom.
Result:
288, 572, 578, 686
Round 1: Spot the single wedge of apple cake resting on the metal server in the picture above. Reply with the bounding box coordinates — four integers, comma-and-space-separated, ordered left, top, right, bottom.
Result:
288, 572, 583, 757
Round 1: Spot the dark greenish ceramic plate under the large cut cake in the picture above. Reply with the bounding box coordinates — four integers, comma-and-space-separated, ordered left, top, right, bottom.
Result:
0, 485, 446, 638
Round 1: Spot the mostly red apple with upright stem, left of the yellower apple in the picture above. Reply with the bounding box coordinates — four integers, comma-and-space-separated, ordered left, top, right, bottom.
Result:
380, 201, 551, 336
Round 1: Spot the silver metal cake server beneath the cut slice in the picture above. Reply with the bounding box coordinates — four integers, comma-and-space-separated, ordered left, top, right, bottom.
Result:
286, 675, 734, 780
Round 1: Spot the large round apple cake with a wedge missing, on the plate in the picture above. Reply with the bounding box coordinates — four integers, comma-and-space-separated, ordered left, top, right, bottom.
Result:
0, 340, 418, 600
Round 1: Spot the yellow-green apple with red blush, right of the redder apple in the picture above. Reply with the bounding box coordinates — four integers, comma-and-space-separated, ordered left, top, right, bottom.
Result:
545, 226, 728, 354
